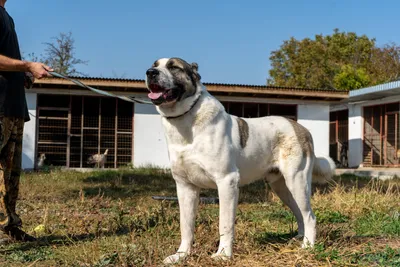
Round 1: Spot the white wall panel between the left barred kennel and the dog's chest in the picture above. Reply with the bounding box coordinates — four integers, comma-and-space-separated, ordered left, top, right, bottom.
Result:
133, 104, 170, 168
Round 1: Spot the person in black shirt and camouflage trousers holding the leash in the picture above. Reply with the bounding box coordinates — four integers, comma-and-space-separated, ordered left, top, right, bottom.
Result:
0, 0, 53, 244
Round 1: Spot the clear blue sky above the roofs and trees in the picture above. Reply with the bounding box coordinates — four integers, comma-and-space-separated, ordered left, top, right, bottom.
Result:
6, 0, 400, 84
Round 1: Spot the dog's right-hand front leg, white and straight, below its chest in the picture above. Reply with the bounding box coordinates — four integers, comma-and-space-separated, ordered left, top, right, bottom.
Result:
212, 172, 239, 260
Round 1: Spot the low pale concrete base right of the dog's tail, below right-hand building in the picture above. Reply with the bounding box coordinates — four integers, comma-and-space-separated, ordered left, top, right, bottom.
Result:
335, 168, 400, 180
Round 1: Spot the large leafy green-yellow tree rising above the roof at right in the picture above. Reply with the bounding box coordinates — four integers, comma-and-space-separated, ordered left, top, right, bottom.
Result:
267, 29, 400, 90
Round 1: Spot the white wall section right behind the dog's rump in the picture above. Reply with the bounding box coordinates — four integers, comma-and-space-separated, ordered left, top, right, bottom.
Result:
297, 104, 329, 156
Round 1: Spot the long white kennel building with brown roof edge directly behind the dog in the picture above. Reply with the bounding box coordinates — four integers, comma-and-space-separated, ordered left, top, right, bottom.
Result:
22, 77, 348, 169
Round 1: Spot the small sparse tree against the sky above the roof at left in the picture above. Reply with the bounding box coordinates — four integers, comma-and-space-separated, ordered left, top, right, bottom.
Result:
42, 32, 88, 76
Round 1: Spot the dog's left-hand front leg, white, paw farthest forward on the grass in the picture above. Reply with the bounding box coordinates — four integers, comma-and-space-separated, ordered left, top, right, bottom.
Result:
164, 181, 200, 264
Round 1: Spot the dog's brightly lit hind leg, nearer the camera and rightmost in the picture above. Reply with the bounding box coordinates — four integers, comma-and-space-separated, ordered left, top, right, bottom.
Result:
281, 157, 316, 247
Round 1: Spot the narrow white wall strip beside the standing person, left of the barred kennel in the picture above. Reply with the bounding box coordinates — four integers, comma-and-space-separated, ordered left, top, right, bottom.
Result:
22, 92, 37, 169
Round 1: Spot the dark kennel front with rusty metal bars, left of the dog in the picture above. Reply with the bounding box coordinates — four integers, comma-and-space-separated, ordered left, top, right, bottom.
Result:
35, 94, 134, 168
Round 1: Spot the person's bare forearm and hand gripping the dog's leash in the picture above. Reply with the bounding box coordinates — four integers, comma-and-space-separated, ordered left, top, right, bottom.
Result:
0, 55, 53, 79
